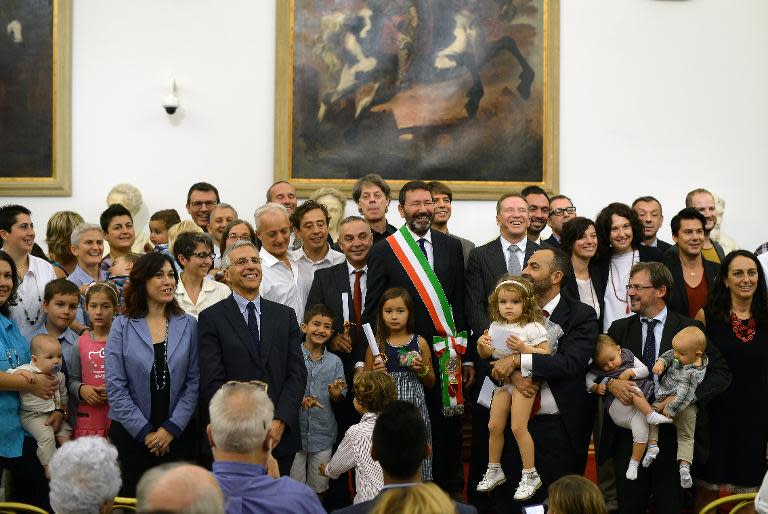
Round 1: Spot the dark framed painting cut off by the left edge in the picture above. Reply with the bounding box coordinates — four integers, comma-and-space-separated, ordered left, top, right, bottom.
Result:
0, 0, 72, 196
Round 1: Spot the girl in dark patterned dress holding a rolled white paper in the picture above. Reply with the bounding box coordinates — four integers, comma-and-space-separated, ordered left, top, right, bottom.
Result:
365, 287, 435, 481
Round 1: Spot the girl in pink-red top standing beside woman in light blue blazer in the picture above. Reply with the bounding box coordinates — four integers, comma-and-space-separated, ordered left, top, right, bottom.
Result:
68, 282, 119, 437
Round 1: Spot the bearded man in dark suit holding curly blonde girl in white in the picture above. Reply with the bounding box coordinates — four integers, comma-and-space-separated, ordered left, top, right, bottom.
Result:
493, 248, 599, 505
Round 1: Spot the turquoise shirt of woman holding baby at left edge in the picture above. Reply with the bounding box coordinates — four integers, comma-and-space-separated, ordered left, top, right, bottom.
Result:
0, 314, 32, 459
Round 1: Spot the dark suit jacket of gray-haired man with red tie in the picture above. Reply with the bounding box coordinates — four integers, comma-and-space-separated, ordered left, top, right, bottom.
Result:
305, 261, 367, 378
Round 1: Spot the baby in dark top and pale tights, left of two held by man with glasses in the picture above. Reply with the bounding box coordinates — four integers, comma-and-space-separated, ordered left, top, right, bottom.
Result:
586, 334, 672, 480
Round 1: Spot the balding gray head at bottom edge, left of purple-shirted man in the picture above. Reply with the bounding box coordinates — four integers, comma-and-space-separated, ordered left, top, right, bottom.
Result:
136, 462, 224, 514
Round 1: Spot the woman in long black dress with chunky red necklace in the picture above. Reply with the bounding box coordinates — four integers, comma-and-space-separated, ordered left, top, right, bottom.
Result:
696, 250, 768, 510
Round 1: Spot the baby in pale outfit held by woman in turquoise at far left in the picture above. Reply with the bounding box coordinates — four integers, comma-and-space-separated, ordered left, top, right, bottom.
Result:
8, 334, 72, 478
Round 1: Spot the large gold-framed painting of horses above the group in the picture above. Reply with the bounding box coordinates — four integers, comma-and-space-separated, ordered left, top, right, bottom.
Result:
275, 0, 560, 199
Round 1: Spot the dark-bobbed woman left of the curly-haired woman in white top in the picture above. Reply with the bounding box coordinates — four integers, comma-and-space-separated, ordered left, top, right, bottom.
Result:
560, 216, 605, 319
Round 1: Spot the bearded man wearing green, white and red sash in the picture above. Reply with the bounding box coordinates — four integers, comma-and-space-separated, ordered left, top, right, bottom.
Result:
363, 180, 474, 496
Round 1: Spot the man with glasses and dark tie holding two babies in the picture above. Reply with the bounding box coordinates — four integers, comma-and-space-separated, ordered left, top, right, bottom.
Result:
598, 262, 730, 514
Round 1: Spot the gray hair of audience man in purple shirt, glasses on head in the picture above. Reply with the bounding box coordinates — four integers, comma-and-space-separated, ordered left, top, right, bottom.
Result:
208, 383, 275, 455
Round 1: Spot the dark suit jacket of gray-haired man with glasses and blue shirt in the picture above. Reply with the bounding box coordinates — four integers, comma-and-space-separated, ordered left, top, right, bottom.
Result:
197, 295, 307, 455
